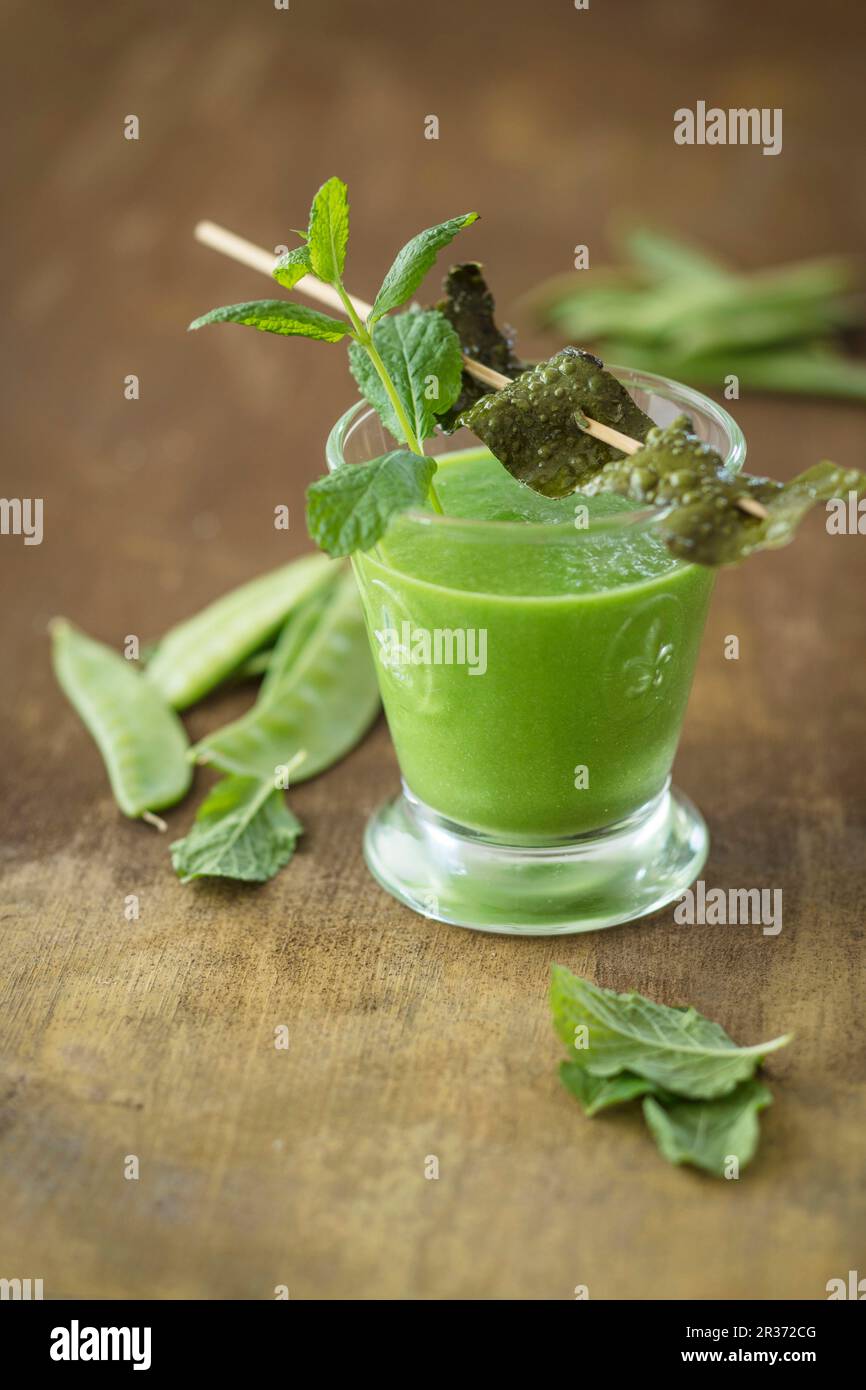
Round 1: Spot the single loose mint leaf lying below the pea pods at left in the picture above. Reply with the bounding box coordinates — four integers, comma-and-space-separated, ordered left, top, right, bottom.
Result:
171, 777, 303, 883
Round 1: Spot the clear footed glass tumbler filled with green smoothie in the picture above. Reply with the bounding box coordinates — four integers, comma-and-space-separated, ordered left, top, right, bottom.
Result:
327, 367, 745, 935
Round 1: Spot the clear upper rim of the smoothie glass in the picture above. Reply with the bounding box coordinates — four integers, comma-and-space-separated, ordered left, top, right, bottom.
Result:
325, 363, 746, 543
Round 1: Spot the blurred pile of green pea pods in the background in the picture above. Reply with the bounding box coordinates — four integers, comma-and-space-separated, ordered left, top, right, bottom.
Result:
525, 227, 866, 400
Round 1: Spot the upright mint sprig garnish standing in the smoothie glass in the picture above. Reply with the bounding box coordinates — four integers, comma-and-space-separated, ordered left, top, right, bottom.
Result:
189, 178, 478, 555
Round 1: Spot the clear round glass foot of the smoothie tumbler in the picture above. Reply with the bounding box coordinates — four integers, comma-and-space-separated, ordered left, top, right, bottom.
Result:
364, 783, 709, 937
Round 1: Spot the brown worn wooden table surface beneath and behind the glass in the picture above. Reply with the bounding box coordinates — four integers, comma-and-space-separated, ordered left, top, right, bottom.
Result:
0, 0, 866, 1300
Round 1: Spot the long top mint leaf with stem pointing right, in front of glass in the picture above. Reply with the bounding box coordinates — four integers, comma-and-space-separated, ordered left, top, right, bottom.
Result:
550, 966, 791, 1099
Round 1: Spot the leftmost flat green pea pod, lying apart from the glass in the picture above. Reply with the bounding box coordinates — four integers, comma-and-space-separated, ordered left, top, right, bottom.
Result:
51, 619, 192, 828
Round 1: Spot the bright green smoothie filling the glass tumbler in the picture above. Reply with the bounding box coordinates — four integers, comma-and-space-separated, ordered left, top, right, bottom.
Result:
353, 449, 714, 842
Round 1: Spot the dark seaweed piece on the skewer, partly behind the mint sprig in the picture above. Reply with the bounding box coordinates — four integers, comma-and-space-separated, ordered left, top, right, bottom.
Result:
435, 261, 530, 430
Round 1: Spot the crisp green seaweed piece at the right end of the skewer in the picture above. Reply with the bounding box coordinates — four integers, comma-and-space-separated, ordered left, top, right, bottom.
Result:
582, 416, 866, 566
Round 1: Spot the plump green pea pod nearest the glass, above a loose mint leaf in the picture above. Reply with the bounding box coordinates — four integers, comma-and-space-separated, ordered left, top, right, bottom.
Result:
192, 574, 379, 783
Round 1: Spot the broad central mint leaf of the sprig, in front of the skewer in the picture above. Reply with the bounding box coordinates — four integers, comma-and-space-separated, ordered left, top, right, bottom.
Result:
349, 309, 463, 443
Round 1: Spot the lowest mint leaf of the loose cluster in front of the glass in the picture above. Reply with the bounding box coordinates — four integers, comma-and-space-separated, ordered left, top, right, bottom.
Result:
644, 1081, 773, 1177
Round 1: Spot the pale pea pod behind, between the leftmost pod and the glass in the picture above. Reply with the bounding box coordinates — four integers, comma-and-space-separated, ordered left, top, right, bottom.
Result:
147, 555, 339, 709
